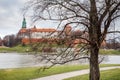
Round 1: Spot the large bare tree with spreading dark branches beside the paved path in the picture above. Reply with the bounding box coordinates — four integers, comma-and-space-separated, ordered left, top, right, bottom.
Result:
26, 0, 120, 80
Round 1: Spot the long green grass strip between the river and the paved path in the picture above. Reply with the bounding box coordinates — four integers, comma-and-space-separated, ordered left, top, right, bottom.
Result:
0, 64, 120, 80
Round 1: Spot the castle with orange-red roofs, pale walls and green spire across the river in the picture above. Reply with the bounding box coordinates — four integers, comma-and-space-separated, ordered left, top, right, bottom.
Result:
17, 18, 106, 46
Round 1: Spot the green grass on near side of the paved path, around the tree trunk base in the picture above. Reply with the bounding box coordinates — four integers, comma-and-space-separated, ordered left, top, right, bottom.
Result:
64, 69, 120, 80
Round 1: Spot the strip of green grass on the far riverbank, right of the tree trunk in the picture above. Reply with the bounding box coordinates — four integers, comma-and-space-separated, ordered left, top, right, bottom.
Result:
100, 49, 120, 55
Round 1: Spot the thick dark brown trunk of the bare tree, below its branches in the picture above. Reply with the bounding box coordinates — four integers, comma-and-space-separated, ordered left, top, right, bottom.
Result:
89, 45, 100, 80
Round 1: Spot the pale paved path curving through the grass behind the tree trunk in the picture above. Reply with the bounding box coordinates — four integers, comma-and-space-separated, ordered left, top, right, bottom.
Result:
34, 66, 120, 80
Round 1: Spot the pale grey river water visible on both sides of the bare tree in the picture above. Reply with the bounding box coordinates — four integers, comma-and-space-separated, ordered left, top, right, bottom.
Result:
0, 53, 120, 69
